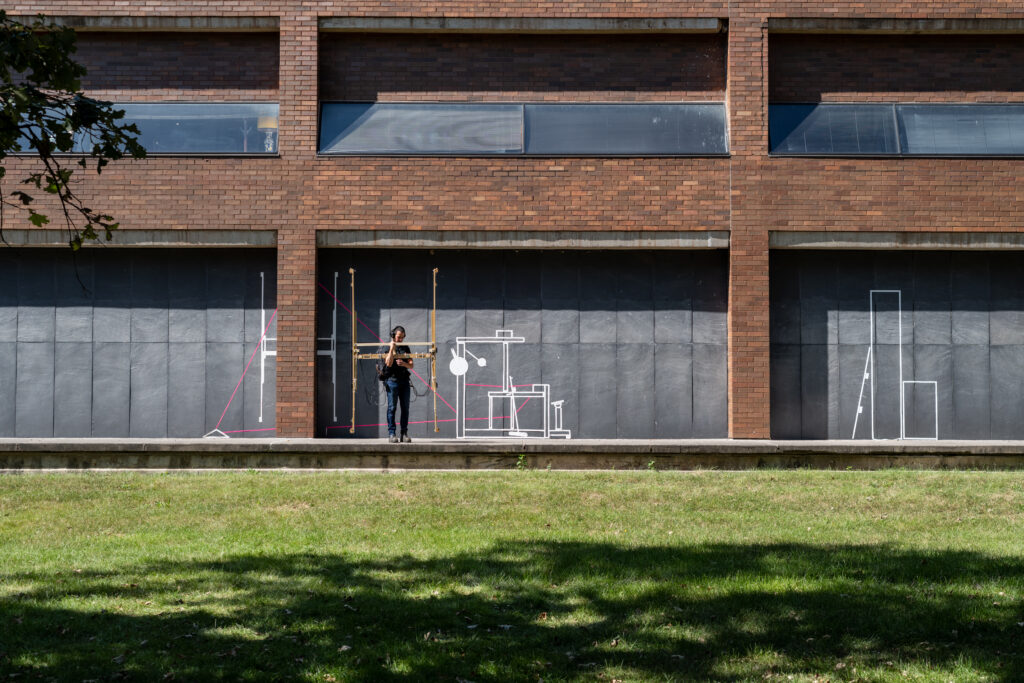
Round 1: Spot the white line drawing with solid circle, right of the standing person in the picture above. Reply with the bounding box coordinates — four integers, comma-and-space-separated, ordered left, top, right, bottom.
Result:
449, 330, 572, 439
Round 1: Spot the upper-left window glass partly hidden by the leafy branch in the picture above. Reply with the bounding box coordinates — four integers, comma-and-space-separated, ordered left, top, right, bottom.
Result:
85, 102, 278, 155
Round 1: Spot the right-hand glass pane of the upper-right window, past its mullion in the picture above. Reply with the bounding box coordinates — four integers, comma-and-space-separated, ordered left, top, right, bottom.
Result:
897, 104, 1024, 156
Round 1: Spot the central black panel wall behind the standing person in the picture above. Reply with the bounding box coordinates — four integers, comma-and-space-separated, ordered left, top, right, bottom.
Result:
316, 250, 728, 438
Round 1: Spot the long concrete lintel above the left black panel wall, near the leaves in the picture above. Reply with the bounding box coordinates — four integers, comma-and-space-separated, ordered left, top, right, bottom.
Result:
0, 229, 278, 249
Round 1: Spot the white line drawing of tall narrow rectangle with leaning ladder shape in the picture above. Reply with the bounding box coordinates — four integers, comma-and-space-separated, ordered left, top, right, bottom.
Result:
850, 290, 939, 440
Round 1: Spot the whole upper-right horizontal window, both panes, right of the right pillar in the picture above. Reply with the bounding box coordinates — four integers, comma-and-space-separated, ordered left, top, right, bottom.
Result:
768, 103, 1024, 157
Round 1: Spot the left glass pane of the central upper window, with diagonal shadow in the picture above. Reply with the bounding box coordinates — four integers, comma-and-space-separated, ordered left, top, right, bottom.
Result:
319, 102, 522, 155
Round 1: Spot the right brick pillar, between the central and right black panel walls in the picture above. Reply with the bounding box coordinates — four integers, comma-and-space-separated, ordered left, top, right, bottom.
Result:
727, 17, 771, 438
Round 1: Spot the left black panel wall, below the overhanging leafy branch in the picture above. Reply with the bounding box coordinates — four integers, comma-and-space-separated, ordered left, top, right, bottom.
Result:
0, 248, 276, 437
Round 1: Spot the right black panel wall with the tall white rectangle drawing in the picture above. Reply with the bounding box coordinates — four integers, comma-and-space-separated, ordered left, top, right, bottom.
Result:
771, 251, 1024, 439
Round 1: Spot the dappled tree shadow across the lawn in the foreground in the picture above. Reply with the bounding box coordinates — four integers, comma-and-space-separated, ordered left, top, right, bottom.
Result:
0, 542, 1024, 681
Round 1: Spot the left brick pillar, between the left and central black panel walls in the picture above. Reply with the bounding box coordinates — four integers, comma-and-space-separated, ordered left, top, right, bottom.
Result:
276, 15, 317, 437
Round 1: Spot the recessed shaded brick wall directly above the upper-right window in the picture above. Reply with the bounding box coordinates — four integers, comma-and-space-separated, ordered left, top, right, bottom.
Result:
769, 35, 1024, 102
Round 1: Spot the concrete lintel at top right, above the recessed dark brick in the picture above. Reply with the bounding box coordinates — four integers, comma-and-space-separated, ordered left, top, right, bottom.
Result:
768, 16, 1024, 34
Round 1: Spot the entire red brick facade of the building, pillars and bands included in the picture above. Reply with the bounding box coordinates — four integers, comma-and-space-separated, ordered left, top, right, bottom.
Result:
5, 0, 1024, 438
